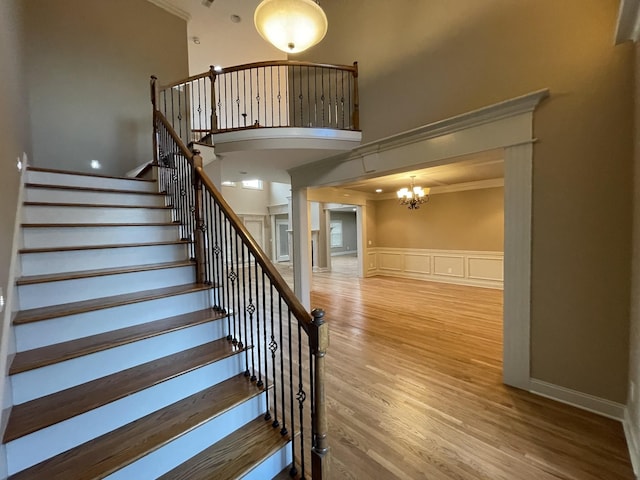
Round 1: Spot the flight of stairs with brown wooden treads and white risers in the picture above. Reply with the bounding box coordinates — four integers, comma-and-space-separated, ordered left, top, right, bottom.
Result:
3, 168, 292, 480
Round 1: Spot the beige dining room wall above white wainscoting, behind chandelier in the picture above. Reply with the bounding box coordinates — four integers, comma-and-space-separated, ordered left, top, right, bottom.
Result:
372, 187, 504, 252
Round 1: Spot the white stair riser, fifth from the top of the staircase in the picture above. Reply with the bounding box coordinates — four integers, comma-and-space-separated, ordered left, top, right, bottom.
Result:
20, 244, 188, 276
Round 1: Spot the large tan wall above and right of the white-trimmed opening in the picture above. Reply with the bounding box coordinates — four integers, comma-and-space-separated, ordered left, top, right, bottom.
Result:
304, 0, 633, 402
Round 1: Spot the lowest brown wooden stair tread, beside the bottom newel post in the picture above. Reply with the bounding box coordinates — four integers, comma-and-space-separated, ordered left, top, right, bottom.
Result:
158, 416, 290, 480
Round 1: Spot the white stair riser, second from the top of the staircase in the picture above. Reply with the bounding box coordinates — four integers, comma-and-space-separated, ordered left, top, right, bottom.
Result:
25, 187, 167, 206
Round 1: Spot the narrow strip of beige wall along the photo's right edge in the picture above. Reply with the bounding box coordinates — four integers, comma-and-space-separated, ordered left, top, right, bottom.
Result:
627, 43, 640, 455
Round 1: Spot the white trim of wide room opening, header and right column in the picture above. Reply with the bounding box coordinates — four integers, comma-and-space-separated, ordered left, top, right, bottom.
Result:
289, 89, 549, 390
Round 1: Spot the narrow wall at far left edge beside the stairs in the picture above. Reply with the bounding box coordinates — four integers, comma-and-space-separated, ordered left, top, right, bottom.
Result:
0, 0, 30, 302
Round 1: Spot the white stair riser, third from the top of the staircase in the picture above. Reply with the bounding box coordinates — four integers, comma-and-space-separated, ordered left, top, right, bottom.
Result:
22, 205, 171, 223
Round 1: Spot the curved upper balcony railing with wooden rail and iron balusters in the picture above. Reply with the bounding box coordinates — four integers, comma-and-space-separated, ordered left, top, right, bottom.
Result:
152, 60, 360, 143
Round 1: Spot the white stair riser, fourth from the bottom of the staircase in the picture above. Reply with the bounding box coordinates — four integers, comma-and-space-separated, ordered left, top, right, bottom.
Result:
11, 322, 231, 404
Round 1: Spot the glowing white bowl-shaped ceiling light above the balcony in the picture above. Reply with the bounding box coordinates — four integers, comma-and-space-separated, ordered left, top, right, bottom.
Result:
253, 0, 328, 53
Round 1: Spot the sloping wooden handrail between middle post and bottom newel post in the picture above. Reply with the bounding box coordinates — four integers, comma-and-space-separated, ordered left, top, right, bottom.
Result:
195, 167, 313, 334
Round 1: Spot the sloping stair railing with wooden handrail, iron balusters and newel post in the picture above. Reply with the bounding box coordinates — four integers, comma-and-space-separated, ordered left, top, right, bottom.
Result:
152, 107, 330, 480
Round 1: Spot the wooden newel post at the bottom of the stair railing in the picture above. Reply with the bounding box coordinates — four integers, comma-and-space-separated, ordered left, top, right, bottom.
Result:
310, 308, 329, 480
